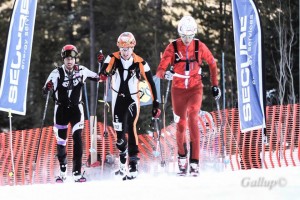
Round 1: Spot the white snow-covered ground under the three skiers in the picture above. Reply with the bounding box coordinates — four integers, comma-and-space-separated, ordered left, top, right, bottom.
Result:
0, 167, 300, 200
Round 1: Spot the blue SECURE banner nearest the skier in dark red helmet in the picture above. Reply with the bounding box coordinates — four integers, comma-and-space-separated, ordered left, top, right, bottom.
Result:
0, 0, 37, 115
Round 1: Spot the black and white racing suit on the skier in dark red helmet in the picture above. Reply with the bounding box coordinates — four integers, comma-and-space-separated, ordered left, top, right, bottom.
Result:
44, 65, 99, 174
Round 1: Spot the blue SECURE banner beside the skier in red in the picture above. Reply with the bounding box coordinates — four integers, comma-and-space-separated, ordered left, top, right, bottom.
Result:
232, 0, 265, 132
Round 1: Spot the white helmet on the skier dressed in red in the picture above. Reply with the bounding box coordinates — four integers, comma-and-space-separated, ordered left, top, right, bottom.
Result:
178, 16, 197, 35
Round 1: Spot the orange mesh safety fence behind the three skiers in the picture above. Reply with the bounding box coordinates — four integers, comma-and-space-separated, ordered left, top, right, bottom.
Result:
0, 104, 300, 185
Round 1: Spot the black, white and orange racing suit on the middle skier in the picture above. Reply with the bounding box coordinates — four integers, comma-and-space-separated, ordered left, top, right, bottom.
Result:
101, 51, 157, 161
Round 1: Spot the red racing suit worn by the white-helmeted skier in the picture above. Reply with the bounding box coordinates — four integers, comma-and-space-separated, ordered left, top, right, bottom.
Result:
156, 38, 218, 163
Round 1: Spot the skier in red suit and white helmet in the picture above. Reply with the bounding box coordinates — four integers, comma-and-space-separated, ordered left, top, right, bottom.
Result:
156, 16, 221, 176
